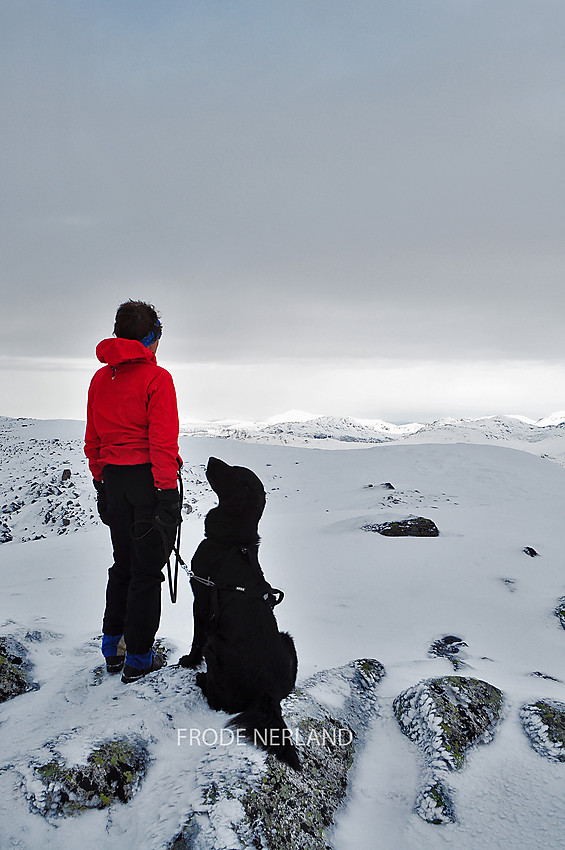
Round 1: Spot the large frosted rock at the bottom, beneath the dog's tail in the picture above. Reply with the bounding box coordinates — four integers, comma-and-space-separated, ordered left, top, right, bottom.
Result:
168, 659, 385, 850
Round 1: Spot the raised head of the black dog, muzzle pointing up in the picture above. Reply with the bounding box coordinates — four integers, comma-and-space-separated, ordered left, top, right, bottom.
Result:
204, 457, 265, 544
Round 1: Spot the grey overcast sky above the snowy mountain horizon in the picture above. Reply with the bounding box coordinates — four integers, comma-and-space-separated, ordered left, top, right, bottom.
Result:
0, 0, 565, 421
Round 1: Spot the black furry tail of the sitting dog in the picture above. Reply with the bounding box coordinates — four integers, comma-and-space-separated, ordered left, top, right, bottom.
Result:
228, 694, 302, 770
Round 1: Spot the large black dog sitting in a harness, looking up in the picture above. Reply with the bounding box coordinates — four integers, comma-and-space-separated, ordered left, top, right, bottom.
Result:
180, 457, 300, 770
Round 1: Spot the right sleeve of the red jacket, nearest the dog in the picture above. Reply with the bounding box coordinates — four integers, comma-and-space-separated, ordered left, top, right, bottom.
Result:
147, 368, 179, 490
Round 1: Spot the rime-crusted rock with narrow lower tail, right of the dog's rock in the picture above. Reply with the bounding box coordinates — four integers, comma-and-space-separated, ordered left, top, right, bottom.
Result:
393, 676, 503, 824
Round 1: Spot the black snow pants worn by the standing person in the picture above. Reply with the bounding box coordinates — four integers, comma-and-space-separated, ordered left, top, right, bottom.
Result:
101, 463, 174, 655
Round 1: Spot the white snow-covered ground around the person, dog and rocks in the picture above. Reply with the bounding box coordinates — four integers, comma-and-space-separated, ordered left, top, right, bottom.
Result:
0, 416, 565, 850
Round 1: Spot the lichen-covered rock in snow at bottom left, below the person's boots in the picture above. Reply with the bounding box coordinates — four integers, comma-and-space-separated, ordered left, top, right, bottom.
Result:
25, 739, 149, 817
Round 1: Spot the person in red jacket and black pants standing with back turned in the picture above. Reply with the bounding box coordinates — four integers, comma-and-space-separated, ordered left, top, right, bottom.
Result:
84, 301, 182, 683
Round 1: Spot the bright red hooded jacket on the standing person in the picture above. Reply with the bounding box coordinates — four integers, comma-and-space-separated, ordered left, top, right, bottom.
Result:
84, 338, 179, 490
